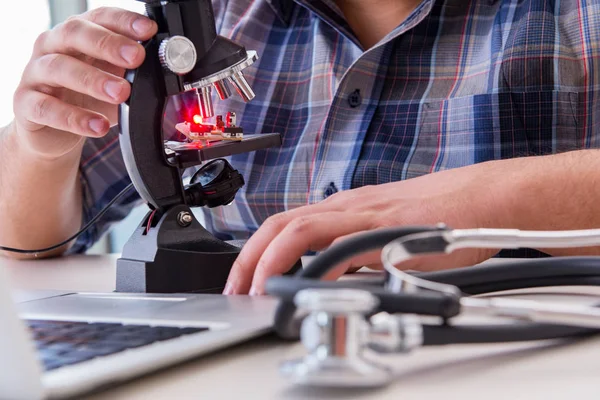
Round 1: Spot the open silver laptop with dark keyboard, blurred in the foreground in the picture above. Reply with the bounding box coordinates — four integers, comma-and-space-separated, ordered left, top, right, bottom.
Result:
0, 267, 276, 400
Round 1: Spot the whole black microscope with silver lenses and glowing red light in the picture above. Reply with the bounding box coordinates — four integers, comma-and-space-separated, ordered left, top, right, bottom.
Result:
116, 0, 290, 293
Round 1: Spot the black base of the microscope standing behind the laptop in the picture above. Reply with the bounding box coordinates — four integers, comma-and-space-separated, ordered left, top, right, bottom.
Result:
116, 205, 302, 293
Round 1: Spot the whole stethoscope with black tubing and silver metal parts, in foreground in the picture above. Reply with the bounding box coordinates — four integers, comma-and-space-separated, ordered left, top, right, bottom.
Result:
266, 225, 600, 387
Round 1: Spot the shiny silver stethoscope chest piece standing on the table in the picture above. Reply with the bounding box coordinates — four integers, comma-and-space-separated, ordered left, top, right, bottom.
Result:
281, 289, 420, 387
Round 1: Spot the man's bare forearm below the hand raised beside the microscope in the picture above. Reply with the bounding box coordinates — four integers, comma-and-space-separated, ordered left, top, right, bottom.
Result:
0, 125, 82, 258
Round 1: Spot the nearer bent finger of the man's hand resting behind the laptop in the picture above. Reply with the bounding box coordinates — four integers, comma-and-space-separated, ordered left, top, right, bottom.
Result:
245, 211, 375, 294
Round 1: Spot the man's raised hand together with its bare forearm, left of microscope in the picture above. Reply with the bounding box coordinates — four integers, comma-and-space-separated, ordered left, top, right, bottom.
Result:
0, 8, 157, 258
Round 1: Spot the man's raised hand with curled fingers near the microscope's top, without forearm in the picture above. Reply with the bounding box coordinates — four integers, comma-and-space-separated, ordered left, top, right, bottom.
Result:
13, 8, 157, 159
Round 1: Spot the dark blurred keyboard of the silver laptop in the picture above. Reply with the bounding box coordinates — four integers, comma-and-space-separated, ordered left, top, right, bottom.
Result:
25, 320, 208, 371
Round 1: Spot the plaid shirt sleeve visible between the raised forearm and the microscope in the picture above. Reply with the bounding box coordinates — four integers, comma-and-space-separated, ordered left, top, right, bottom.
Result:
69, 126, 142, 254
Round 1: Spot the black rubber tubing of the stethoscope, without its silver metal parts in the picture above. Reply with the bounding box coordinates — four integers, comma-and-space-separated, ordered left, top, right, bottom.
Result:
267, 227, 600, 345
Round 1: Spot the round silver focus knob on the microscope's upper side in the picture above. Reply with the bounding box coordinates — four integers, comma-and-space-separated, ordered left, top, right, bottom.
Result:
158, 36, 197, 75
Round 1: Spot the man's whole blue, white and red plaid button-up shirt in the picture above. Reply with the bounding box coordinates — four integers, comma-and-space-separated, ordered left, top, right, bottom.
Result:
75, 0, 600, 251
